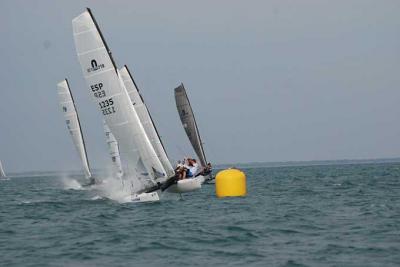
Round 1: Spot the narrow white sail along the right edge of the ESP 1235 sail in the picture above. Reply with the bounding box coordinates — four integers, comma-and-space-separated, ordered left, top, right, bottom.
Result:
119, 65, 175, 177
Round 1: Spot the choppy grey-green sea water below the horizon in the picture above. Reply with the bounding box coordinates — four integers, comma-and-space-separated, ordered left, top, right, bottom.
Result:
0, 163, 400, 266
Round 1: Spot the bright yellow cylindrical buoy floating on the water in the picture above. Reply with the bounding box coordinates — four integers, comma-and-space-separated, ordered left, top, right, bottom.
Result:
215, 169, 246, 197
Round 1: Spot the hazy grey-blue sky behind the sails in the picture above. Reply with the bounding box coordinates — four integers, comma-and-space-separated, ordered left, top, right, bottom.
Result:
0, 0, 400, 172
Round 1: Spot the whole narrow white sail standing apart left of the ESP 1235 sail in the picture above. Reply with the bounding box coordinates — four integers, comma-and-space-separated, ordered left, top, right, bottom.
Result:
57, 79, 92, 179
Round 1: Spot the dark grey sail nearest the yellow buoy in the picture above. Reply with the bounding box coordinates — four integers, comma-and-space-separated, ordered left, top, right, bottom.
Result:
175, 83, 207, 167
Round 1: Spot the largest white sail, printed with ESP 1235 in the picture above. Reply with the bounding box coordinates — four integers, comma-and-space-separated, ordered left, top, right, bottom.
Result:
72, 9, 167, 192
